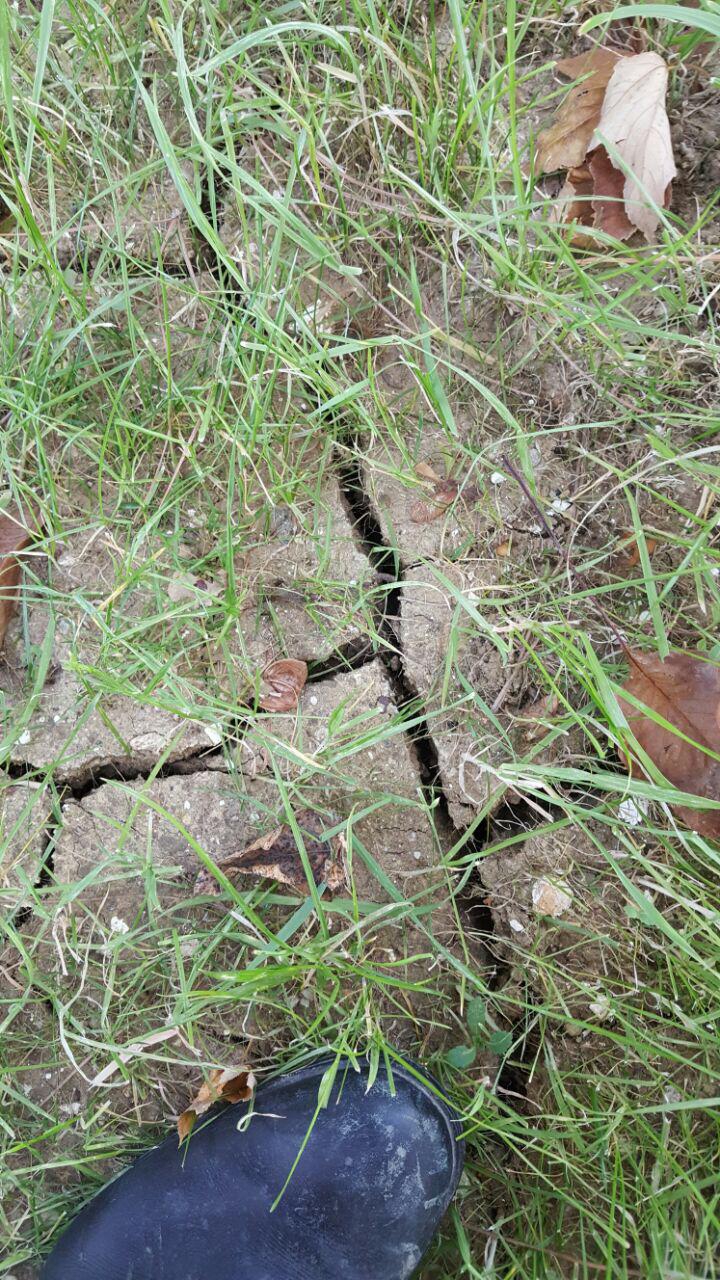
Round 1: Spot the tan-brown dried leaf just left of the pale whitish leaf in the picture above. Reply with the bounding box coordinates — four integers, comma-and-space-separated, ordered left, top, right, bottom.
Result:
536, 49, 624, 174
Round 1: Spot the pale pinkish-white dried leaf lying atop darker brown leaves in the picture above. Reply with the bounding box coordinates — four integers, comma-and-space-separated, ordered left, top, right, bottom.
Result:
596, 54, 676, 239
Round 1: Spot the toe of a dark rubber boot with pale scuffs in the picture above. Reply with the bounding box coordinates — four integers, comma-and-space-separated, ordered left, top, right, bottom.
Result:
42, 1061, 464, 1280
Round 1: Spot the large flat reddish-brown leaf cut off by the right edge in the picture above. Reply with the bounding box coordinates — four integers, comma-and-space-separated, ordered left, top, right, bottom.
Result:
620, 650, 720, 840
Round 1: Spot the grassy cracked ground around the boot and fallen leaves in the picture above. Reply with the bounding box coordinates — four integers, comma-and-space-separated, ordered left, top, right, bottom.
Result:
0, 0, 720, 1280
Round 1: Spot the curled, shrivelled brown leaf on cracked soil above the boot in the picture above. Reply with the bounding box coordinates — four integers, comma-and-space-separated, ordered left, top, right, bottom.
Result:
195, 809, 346, 895
